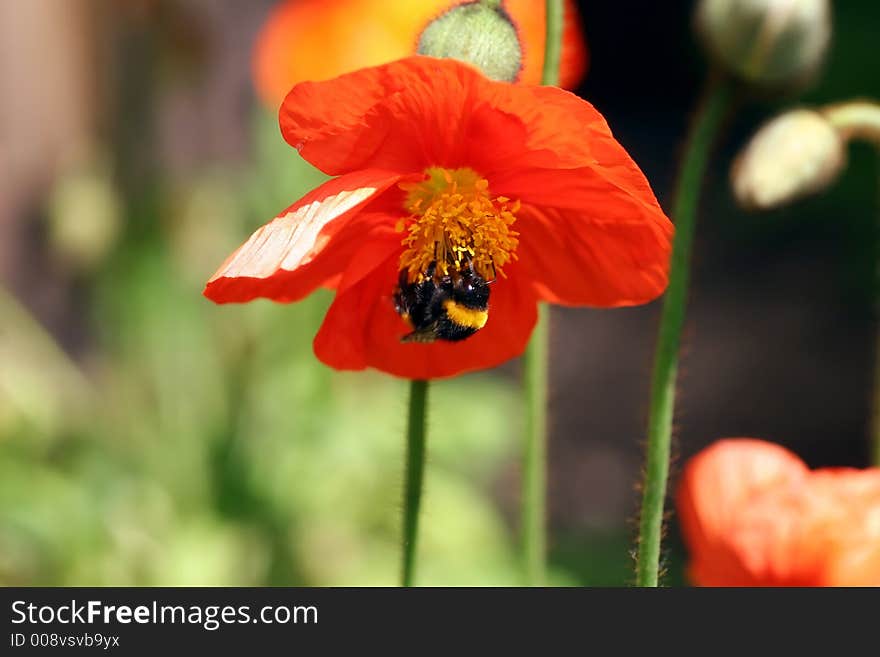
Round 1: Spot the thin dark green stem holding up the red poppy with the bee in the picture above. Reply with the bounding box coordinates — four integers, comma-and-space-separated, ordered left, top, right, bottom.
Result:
402, 381, 428, 586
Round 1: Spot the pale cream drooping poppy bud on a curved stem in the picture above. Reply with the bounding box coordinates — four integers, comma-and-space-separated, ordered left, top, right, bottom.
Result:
731, 109, 846, 209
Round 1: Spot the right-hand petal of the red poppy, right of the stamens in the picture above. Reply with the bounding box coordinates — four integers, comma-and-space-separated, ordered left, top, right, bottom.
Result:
516, 205, 672, 308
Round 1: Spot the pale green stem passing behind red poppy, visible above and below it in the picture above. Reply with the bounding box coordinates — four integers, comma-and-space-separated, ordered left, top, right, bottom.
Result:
521, 0, 563, 586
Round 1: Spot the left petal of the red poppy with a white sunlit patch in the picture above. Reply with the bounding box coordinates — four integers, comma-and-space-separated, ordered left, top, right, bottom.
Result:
204, 170, 403, 303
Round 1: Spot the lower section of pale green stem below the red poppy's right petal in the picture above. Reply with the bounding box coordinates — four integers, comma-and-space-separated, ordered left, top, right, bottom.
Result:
522, 304, 549, 586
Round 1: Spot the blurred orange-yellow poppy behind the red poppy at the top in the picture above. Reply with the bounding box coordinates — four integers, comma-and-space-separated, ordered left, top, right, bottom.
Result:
253, 0, 588, 108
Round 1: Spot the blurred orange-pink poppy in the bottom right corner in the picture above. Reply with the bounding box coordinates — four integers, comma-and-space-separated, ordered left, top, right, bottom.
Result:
677, 439, 880, 586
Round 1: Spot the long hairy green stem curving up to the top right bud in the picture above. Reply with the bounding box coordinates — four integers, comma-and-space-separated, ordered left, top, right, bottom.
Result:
636, 80, 732, 586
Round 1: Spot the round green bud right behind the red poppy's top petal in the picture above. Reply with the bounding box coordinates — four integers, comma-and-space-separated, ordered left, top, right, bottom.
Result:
418, 0, 522, 82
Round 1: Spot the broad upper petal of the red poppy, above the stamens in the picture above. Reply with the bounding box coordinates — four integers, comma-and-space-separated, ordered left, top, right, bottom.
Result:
279, 56, 604, 178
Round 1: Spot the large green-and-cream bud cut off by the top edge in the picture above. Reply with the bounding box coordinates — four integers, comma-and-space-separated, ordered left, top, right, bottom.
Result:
695, 0, 831, 86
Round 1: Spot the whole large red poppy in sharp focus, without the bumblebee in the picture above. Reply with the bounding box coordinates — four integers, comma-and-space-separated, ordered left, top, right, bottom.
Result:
205, 57, 672, 379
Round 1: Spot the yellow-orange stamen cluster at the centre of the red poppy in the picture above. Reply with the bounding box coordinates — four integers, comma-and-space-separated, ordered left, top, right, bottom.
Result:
399, 167, 520, 282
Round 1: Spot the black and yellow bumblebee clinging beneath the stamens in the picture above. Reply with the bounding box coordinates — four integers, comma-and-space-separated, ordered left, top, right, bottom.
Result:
394, 262, 489, 342
